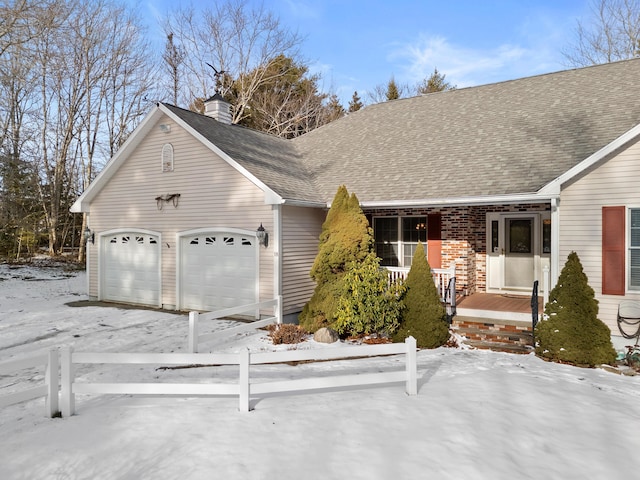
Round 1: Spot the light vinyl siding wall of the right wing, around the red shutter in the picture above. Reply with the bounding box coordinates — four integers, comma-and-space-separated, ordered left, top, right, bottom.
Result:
552, 139, 640, 334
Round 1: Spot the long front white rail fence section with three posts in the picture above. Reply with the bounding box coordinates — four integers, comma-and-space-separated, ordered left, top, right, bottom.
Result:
61, 337, 418, 416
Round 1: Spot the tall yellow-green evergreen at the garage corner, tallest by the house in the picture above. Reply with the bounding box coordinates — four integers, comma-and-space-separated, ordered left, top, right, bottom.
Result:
298, 185, 373, 332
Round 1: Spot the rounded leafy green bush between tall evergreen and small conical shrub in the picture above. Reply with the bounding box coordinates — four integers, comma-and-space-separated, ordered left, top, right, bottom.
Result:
333, 253, 404, 336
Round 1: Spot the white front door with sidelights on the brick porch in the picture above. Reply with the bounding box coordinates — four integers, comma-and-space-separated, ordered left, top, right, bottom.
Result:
487, 212, 550, 292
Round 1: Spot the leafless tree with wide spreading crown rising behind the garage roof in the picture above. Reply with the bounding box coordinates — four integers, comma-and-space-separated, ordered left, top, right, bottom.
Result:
165, 0, 302, 123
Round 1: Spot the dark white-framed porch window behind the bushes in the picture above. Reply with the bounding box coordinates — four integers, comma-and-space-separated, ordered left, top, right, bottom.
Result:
373, 216, 427, 267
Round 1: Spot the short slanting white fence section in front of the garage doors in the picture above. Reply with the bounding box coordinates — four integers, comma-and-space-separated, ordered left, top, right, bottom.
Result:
188, 296, 282, 353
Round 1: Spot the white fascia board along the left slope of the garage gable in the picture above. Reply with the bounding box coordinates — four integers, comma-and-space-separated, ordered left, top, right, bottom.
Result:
69, 106, 163, 213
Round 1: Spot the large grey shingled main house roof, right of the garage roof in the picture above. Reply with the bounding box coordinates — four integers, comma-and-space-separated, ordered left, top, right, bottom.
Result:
292, 59, 640, 203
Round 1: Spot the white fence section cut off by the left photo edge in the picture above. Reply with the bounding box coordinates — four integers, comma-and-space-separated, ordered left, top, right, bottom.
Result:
0, 348, 59, 417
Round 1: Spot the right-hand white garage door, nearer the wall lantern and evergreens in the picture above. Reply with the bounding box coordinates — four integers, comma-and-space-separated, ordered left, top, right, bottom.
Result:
180, 232, 258, 311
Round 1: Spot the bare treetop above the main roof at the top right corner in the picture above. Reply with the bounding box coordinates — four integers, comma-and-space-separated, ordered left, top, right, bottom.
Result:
563, 0, 640, 67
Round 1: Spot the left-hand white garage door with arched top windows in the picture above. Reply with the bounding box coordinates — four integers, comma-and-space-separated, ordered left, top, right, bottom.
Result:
101, 232, 160, 306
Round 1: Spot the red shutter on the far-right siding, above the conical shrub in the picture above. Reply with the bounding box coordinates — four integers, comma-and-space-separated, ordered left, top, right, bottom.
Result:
602, 206, 626, 295
